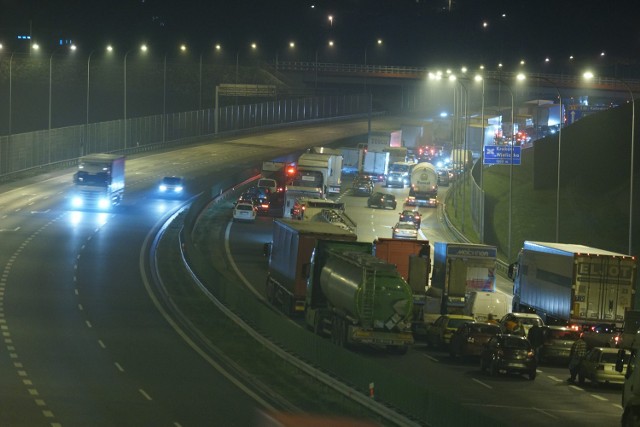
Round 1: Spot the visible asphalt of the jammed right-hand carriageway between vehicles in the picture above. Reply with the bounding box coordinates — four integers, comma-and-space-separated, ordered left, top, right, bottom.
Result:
222, 176, 621, 427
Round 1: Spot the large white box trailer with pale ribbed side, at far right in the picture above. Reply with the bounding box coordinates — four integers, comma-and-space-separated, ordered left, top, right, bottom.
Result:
509, 241, 636, 327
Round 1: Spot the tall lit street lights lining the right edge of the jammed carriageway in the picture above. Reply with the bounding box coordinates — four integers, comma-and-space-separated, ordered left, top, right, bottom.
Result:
429, 70, 635, 255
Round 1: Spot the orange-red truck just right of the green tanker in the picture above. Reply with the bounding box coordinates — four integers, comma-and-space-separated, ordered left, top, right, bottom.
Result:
373, 238, 431, 322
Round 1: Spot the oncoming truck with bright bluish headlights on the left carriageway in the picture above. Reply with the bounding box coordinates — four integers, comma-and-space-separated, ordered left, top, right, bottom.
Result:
71, 154, 125, 209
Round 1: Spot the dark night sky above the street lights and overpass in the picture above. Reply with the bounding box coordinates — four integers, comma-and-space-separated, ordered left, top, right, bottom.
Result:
0, 0, 640, 71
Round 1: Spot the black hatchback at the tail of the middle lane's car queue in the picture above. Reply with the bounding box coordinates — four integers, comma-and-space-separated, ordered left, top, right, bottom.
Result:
480, 334, 538, 380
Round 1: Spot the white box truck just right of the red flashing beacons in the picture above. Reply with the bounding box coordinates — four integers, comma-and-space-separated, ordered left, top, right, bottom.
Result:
293, 147, 342, 196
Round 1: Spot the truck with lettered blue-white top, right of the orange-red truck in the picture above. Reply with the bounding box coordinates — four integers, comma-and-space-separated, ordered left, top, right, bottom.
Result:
428, 242, 498, 314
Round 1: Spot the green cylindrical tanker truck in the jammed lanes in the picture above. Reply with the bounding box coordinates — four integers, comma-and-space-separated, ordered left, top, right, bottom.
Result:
305, 241, 413, 354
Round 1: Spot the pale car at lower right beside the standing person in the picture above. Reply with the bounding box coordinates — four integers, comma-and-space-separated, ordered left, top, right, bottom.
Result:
578, 347, 627, 385
